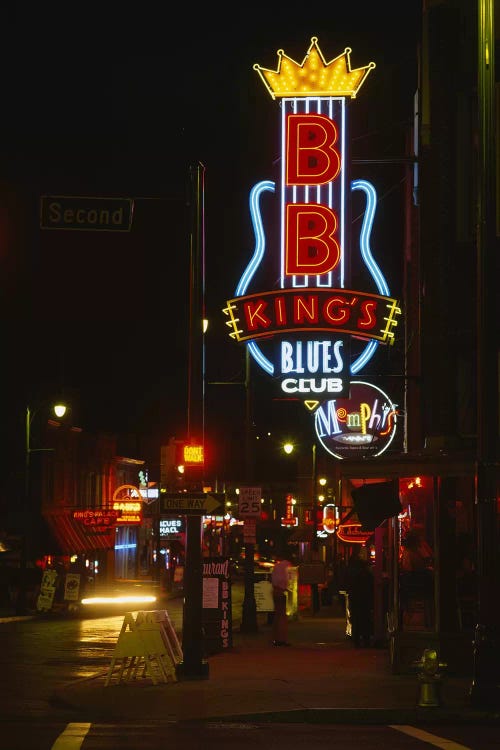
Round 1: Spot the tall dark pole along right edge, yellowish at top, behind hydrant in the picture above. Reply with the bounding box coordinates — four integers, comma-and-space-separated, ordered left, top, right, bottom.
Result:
470, 0, 500, 708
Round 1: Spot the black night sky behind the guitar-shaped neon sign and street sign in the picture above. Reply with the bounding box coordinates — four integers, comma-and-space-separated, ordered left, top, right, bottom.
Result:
0, 1, 420, 476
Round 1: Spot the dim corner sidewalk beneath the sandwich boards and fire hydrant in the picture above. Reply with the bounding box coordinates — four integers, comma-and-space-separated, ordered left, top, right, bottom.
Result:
48, 607, 500, 724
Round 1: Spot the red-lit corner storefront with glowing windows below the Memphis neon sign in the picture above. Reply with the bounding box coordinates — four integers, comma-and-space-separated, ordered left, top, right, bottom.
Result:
337, 454, 477, 674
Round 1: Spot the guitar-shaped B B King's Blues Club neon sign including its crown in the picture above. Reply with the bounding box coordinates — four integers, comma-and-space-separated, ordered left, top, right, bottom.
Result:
224, 37, 401, 399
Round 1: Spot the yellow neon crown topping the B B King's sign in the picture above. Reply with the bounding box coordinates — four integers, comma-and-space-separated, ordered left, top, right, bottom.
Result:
253, 36, 375, 99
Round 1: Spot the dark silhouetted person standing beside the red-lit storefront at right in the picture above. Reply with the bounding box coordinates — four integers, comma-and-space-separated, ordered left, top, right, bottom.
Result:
345, 554, 373, 648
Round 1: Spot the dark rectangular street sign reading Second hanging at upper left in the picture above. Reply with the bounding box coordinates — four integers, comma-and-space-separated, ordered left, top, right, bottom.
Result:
40, 195, 134, 232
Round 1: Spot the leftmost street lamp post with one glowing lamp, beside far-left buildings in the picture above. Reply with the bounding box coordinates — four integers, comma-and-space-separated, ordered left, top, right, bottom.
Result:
16, 402, 66, 615
